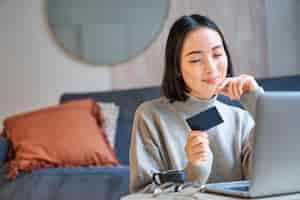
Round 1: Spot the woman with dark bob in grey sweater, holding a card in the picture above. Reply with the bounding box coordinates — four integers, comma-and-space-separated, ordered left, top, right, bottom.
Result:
130, 15, 263, 192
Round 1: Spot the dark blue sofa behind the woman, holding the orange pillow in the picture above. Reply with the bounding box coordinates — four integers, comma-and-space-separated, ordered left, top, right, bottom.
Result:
0, 75, 300, 200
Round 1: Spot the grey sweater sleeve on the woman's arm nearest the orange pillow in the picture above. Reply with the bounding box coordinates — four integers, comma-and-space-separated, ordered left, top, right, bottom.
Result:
129, 107, 164, 193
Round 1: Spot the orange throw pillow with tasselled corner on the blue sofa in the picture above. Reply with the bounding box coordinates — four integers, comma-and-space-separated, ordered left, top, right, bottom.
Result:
4, 99, 120, 179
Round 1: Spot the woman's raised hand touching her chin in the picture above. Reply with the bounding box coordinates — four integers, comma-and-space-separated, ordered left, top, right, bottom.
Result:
216, 74, 258, 100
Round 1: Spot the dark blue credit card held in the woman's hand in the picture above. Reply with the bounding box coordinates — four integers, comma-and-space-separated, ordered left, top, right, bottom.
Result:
186, 106, 224, 131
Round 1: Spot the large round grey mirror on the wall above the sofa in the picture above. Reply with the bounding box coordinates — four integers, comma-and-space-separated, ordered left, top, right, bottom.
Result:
47, 0, 169, 65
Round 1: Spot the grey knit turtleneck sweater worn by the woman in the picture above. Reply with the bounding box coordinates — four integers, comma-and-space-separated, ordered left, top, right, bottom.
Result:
130, 87, 263, 192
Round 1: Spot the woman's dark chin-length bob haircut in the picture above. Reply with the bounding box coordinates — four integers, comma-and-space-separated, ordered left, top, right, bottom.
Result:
161, 15, 233, 102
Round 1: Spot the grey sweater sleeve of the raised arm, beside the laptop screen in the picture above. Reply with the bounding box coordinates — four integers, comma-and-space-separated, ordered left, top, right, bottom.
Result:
241, 87, 264, 179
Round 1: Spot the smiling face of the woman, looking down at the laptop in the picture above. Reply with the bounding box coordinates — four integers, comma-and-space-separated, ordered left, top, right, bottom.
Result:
180, 27, 228, 99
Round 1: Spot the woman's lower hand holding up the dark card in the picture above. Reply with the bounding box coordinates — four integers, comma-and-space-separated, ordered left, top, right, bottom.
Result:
185, 131, 210, 166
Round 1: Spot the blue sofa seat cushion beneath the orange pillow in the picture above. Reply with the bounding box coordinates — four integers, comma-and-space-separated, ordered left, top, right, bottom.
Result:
0, 166, 129, 200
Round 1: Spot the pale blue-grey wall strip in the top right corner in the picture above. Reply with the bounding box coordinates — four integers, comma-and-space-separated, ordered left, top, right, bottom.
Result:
265, 0, 300, 76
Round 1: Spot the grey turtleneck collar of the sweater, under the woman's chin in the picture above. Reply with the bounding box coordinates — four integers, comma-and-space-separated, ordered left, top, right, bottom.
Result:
171, 93, 218, 118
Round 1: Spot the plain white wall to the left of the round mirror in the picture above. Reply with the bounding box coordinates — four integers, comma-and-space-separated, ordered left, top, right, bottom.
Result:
0, 0, 112, 127
